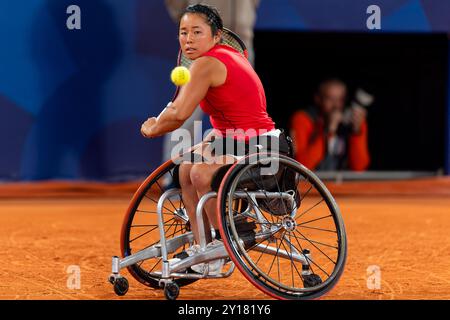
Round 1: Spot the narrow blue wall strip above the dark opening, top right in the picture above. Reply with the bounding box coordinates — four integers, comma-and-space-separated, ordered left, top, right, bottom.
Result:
257, 0, 450, 32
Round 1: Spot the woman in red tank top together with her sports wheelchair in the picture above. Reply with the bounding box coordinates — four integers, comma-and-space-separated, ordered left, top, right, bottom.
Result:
109, 4, 347, 300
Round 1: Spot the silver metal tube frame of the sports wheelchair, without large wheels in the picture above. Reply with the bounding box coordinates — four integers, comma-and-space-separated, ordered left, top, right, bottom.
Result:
109, 152, 343, 300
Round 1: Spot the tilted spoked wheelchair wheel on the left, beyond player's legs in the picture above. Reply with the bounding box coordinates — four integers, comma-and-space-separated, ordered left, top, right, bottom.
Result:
120, 160, 196, 288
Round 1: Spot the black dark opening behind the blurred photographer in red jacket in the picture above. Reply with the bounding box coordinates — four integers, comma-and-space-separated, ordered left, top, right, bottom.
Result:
255, 31, 448, 171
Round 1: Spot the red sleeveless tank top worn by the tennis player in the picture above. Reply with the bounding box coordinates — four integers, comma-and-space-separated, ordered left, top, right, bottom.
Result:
200, 45, 275, 140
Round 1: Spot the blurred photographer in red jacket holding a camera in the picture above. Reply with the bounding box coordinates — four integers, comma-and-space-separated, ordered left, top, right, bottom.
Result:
290, 78, 373, 171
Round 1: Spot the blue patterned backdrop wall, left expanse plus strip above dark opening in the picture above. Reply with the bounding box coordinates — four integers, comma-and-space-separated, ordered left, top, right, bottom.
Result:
0, 0, 450, 181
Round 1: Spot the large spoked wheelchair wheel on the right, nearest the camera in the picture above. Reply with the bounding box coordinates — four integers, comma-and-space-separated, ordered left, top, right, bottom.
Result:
217, 153, 347, 300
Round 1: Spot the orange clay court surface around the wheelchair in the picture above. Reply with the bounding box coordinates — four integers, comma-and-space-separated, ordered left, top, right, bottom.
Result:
0, 178, 450, 299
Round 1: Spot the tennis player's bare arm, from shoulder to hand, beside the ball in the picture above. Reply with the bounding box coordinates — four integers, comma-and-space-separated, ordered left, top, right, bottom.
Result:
141, 57, 218, 138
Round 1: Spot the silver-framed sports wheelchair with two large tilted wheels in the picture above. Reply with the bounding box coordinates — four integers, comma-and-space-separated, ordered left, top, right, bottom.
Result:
109, 152, 347, 300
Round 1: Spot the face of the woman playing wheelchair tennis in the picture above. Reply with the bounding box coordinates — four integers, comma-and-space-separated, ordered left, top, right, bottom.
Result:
179, 13, 220, 60
